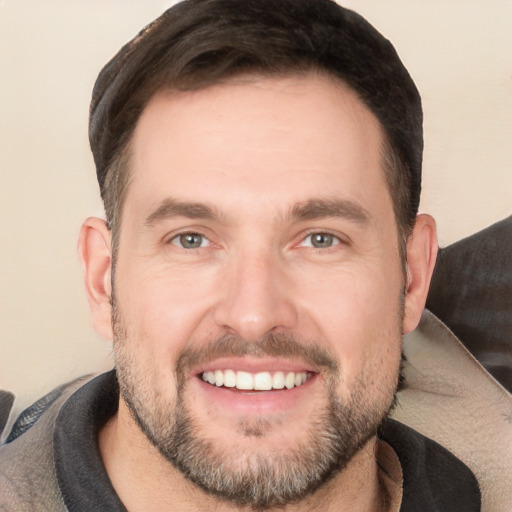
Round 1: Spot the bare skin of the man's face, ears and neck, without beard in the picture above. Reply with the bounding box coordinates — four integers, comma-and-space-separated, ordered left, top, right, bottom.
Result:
79, 75, 437, 511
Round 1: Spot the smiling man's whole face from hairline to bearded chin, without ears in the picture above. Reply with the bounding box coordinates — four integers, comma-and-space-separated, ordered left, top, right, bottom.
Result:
114, 76, 404, 508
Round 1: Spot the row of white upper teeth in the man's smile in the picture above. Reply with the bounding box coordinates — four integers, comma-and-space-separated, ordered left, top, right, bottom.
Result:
202, 370, 308, 391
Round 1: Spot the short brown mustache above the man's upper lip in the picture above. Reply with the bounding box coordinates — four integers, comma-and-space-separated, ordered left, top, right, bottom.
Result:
176, 333, 339, 381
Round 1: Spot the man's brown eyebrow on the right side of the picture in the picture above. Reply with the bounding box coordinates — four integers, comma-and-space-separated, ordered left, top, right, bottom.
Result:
289, 199, 372, 224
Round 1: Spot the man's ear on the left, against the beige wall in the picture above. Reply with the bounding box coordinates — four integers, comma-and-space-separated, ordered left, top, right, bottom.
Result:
78, 217, 112, 340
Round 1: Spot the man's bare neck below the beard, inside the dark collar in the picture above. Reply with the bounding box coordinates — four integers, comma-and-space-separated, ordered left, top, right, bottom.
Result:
98, 400, 387, 512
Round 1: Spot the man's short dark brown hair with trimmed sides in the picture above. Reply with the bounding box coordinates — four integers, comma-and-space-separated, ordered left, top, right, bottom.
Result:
89, 0, 423, 256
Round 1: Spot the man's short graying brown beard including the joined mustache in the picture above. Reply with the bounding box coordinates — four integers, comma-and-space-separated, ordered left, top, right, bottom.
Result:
113, 302, 398, 510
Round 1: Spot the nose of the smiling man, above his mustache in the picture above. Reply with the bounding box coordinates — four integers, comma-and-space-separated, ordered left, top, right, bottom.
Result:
214, 250, 298, 341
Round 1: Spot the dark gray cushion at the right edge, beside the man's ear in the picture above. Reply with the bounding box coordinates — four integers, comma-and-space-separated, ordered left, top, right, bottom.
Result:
427, 216, 512, 392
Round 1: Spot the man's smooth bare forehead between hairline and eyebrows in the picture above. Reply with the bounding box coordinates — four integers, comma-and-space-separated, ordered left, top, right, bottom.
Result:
128, 74, 387, 219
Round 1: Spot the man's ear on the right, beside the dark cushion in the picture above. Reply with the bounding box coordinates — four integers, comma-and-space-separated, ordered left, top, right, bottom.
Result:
403, 215, 438, 334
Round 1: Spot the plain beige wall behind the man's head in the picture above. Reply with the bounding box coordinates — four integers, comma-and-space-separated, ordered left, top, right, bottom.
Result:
0, 0, 512, 414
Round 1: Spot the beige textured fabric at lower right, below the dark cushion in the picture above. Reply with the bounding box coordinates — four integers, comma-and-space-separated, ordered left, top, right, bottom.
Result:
392, 311, 512, 512
